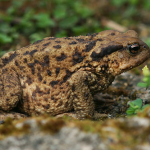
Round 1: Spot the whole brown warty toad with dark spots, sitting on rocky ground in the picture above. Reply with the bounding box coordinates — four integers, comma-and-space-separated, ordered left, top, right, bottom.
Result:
0, 30, 150, 119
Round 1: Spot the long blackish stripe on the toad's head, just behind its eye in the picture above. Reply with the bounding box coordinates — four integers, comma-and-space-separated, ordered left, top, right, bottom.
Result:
91, 44, 123, 61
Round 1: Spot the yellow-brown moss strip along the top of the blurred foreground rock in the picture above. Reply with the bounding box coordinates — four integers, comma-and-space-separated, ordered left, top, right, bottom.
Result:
0, 108, 150, 150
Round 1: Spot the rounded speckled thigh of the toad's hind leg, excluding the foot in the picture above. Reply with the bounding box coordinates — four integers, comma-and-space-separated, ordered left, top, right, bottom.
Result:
0, 71, 22, 112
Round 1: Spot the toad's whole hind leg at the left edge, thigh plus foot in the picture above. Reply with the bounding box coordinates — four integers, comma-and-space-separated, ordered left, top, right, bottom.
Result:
0, 70, 27, 124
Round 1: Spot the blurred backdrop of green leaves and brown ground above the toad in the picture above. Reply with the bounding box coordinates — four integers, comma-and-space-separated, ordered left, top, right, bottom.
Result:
0, 0, 150, 56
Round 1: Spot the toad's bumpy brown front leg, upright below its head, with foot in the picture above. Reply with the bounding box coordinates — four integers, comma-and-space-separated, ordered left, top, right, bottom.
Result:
60, 71, 106, 119
